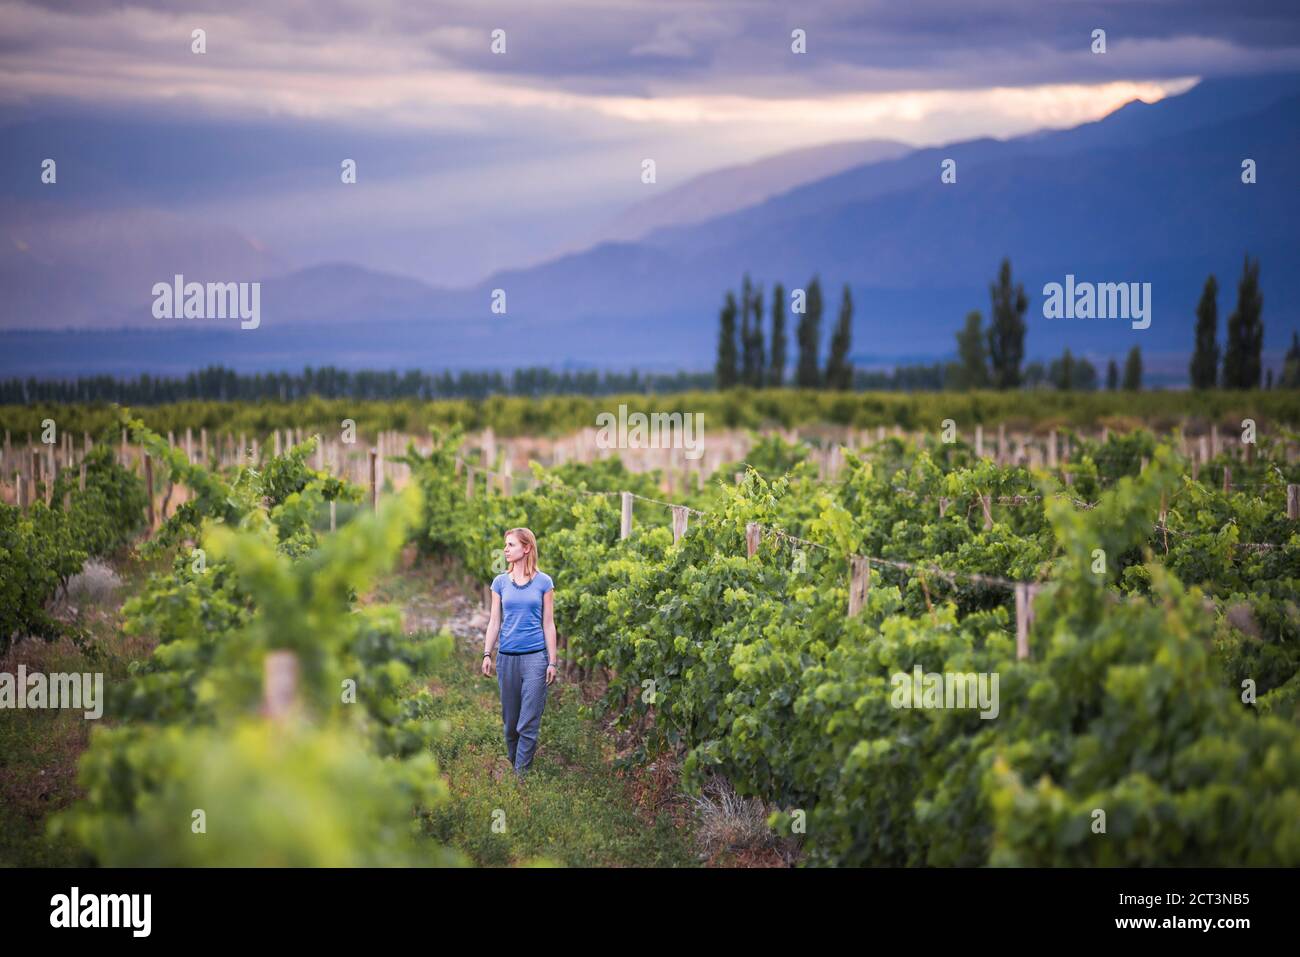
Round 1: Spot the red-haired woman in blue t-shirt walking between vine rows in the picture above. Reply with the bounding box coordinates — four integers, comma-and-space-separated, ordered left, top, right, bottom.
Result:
482, 528, 555, 778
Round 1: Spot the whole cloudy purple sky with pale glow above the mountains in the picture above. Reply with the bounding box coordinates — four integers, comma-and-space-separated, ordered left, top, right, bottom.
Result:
0, 0, 1300, 285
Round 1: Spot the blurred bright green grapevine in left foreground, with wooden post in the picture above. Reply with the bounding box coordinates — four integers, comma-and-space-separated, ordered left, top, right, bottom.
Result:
51, 442, 455, 866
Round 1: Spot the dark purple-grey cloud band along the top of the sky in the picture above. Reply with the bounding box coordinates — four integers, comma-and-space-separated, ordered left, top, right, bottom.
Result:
15, 0, 1300, 95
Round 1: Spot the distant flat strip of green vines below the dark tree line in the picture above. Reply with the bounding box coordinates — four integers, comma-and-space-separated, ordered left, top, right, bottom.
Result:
0, 387, 1300, 446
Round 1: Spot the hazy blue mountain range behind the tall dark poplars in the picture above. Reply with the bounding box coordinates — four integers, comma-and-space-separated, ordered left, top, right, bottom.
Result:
0, 74, 1300, 376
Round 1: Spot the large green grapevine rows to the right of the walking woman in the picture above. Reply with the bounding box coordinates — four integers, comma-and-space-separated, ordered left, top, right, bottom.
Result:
408, 421, 1300, 866
